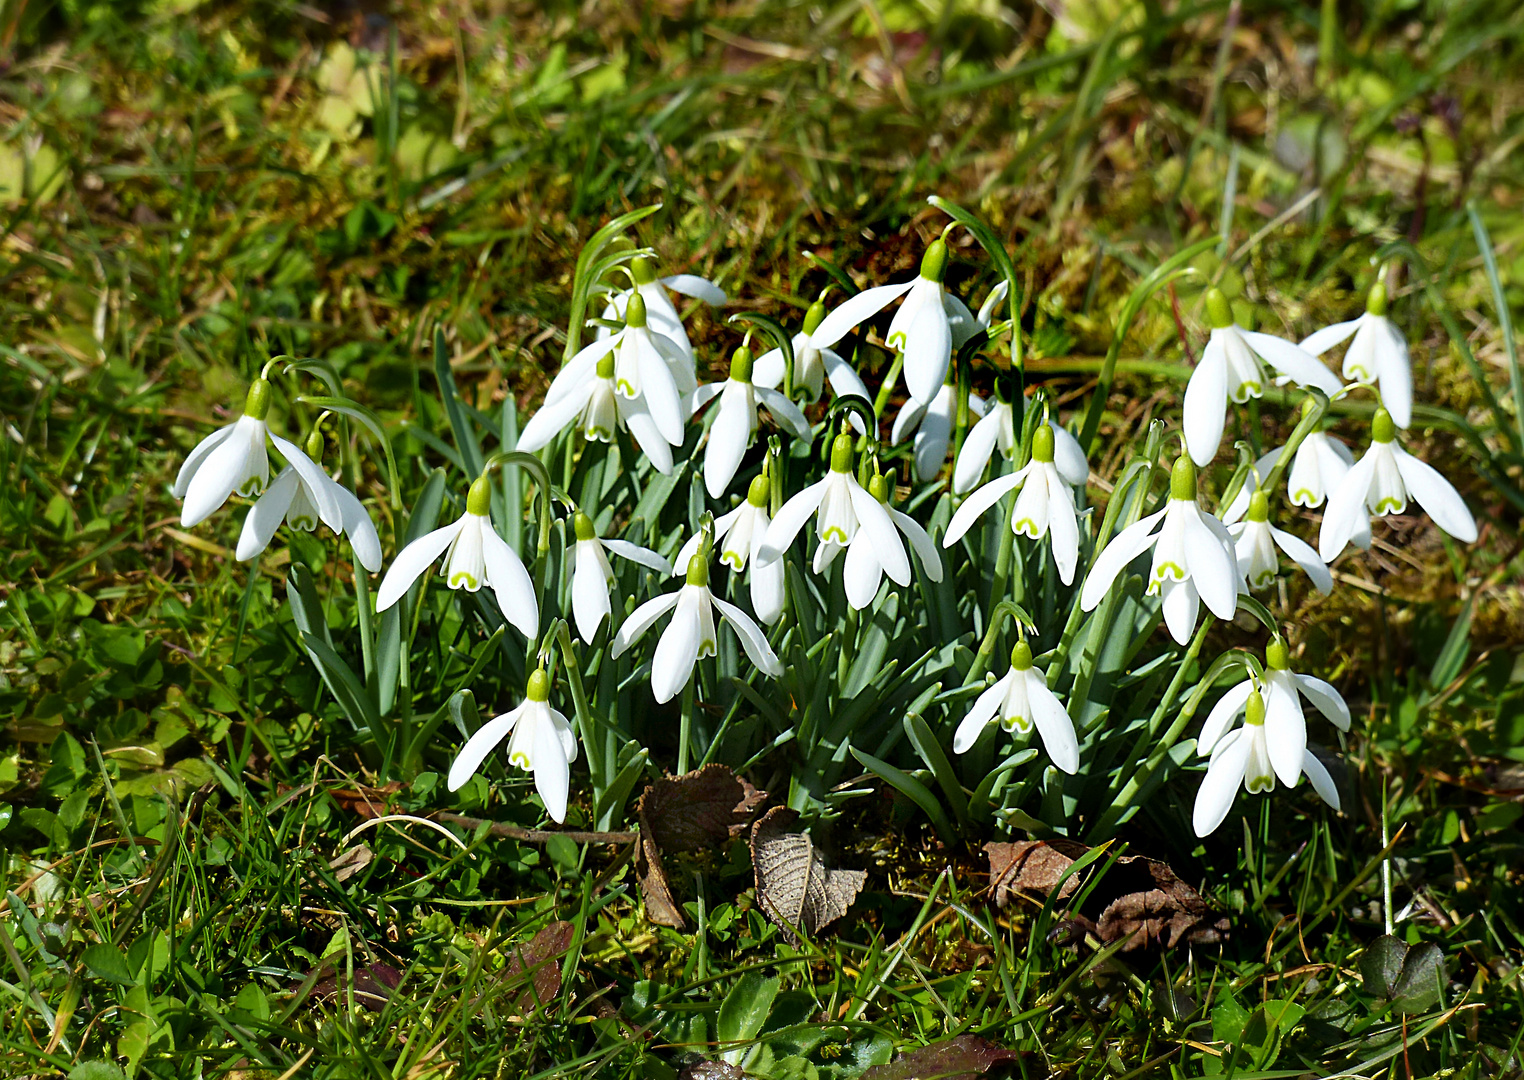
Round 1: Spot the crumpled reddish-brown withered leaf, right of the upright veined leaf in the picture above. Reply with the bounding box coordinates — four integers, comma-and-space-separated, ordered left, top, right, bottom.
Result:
985, 839, 1228, 952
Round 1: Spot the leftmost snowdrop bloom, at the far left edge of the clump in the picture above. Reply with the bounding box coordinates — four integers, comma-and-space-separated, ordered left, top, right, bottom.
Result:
171, 376, 344, 533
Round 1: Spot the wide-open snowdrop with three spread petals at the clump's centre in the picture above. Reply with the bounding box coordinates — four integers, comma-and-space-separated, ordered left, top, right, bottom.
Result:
756, 433, 910, 585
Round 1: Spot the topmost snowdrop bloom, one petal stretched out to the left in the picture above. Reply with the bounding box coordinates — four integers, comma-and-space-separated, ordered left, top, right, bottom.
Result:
812, 239, 950, 401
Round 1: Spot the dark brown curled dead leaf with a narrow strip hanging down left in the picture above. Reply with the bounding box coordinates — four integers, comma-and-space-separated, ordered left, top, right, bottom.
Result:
636, 765, 767, 929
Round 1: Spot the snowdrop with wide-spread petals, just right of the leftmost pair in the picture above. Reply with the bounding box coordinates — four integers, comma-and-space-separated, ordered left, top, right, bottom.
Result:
376, 475, 539, 640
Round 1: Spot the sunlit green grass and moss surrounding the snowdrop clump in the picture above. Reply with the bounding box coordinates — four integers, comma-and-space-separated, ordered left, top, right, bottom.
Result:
0, 0, 1524, 1080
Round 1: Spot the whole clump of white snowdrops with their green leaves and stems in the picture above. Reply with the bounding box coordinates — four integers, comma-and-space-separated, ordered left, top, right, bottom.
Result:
174, 198, 1477, 839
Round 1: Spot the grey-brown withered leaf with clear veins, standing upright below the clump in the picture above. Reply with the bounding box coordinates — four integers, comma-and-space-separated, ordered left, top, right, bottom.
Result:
751, 806, 867, 944
